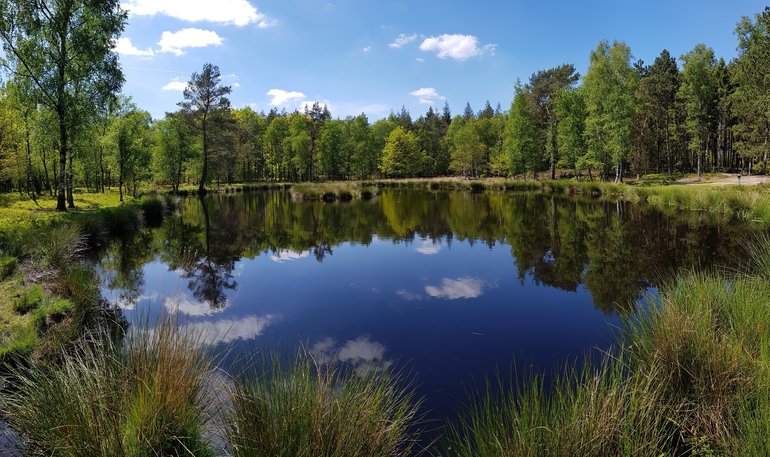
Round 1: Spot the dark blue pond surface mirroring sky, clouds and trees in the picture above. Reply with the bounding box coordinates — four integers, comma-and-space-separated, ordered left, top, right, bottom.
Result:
100, 190, 750, 419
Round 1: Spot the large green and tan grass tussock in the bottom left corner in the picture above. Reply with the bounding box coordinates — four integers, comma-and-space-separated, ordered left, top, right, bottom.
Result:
2, 320, 212, 457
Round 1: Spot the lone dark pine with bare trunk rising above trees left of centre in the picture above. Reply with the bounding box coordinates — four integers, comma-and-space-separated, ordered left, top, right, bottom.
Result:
179, 63, 231, 195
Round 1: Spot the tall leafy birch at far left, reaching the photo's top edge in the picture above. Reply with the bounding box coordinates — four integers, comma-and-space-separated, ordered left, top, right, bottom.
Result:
0, 0, 127, 211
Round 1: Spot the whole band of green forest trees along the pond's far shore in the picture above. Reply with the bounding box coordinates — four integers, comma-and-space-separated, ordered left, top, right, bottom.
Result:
0, 0, 770, 210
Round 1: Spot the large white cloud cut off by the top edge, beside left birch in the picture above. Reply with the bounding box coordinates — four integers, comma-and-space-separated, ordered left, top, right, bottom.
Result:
125, 0, 276, 29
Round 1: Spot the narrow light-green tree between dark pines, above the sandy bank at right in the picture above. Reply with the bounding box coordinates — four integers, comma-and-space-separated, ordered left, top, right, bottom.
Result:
679, 44, 717, 176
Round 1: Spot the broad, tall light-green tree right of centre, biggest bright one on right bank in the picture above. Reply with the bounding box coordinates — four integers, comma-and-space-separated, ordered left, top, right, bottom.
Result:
583, 41, 639, 182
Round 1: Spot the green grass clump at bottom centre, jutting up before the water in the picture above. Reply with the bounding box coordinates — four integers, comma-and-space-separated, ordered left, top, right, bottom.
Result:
228, 357, 418, 457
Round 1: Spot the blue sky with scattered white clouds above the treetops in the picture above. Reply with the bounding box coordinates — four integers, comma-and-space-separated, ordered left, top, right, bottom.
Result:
117, 0, 764, 119
